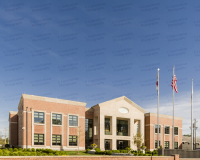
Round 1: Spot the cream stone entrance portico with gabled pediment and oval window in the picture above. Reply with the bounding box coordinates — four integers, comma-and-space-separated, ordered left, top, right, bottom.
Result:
92, 96, 146, 150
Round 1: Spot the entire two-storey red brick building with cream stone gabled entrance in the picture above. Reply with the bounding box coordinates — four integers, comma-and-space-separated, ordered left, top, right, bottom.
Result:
9, 94, 182, 150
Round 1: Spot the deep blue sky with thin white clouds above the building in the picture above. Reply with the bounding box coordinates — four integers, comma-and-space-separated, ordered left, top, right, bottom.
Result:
0, 0, 200, 136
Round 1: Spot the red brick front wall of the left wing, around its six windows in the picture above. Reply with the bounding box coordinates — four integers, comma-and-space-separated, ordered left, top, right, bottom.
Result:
19, 99, 85, 147
